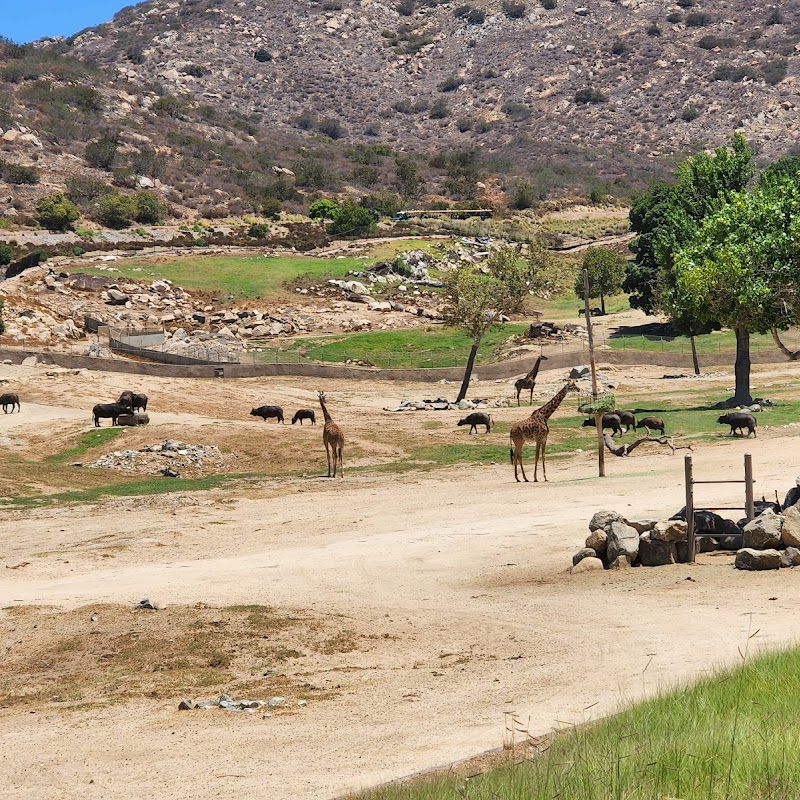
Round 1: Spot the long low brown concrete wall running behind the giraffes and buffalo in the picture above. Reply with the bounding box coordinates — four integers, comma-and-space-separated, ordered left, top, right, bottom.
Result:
0, 347, 788, 383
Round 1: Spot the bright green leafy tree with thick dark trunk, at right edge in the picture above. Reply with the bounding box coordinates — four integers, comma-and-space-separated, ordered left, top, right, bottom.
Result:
664, 175, 800, 403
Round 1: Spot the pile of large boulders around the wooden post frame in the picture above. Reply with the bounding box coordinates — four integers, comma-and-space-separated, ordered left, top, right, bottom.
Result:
572, 494, 800, 572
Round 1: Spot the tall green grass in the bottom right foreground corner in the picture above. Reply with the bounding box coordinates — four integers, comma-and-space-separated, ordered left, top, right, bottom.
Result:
358, 649, 800, 800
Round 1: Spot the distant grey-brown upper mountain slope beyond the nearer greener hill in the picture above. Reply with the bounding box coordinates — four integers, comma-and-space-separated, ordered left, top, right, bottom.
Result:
72, 0, 800, 178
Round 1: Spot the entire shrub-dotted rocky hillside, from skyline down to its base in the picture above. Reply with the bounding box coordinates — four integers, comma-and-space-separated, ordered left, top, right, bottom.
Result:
0, 0, 800, 232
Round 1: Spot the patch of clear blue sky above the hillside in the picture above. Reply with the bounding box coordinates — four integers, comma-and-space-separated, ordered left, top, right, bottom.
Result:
0, 0, 137, 44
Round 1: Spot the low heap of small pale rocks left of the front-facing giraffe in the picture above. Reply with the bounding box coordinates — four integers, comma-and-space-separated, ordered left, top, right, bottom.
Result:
83, 439, 224, 477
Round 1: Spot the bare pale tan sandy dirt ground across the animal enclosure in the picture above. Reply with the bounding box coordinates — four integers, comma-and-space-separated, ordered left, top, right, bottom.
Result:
0, 367, 800, 800
